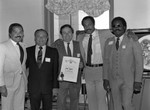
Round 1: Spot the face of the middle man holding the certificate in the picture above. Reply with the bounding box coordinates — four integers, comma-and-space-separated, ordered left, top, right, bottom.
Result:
62, 27, 73, 42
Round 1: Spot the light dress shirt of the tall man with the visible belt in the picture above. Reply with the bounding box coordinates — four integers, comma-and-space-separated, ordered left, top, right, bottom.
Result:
82, 30, 103, 64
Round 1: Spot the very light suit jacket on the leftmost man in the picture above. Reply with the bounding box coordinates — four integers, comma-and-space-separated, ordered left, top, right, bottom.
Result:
0, 40, 27, 90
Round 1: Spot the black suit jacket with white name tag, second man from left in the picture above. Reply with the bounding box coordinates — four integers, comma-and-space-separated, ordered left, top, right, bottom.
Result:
26, 45, 59, 93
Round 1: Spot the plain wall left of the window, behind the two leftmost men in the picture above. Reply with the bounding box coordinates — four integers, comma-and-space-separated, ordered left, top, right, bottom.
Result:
0, 0, 44, 46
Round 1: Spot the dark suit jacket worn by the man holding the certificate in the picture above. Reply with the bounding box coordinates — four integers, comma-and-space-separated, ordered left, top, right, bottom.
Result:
51, 39, 83, 83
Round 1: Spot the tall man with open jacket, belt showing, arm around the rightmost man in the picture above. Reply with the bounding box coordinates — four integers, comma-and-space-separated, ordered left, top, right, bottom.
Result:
77, 16, 112, 110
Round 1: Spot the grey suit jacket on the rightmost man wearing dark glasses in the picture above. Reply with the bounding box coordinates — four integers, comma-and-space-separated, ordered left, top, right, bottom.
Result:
103, 33, 143, 86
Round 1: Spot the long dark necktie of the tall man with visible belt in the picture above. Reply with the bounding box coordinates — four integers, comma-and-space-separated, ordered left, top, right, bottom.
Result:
87, 35, 92, 65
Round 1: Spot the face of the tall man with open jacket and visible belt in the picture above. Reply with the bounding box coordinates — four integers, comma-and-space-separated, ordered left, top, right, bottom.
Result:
83, 19, 95, 34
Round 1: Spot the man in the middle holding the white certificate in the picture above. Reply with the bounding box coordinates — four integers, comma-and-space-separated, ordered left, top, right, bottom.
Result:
52, 24, 83, 110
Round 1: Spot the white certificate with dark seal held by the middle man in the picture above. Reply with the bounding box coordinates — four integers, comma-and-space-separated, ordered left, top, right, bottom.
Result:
58, 56, 80, 82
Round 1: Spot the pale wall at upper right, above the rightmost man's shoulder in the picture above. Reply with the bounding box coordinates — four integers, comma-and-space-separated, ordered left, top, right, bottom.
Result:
114, 0, 150, 29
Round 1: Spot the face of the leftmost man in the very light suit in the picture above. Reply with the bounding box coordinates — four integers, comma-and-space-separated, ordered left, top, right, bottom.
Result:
9, 26, 24, 42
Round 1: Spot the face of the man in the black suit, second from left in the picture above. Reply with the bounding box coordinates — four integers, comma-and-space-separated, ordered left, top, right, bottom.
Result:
35, 31, 48, 46
